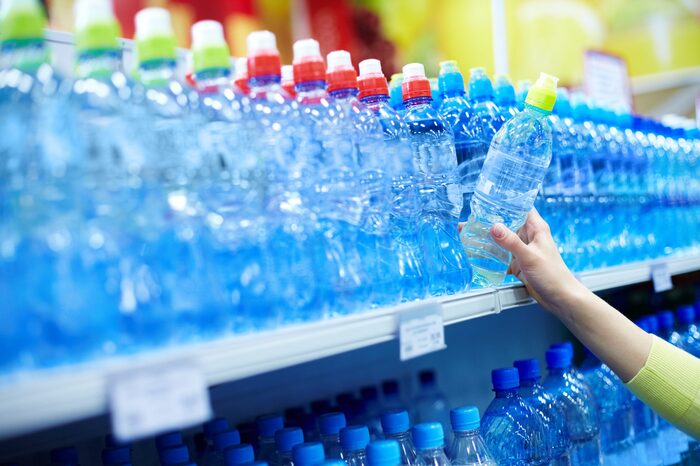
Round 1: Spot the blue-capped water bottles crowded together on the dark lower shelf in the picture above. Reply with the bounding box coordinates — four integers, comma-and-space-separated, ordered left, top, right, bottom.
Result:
42, 305, 700, 466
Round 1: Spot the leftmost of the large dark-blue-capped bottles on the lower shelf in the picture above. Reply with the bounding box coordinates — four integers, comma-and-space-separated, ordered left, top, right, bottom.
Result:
481, 367, 550, 466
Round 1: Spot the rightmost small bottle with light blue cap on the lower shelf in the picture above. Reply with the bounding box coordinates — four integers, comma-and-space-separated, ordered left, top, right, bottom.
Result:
449, 406, 496, 466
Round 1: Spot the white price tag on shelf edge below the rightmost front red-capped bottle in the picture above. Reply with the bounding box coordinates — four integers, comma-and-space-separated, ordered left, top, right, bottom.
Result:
399, 301, 446, 361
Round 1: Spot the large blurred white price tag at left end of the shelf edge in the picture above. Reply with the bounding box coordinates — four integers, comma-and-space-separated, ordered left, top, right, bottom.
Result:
109, 362, 212, 441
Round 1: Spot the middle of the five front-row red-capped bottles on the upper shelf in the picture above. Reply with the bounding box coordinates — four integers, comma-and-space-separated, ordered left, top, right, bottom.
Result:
326, 50, 401, 306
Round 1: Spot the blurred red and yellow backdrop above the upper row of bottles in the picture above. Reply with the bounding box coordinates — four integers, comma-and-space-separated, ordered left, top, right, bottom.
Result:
47, 0, 700, 118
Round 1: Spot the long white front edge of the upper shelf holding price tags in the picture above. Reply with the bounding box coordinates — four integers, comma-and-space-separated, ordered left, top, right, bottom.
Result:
0, 255, 700, 439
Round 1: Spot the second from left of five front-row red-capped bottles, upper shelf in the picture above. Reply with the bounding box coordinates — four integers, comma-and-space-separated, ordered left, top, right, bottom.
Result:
294, 39, 372, 313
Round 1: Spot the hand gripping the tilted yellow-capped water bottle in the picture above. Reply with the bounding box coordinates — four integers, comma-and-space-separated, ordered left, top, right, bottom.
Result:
490, 209, 588, 313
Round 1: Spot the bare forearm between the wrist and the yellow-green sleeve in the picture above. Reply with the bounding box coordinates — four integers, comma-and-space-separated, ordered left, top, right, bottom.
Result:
551, 283, 652, 382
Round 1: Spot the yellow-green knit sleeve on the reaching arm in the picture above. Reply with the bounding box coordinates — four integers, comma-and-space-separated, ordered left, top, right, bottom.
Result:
627, 336, 700, 439
